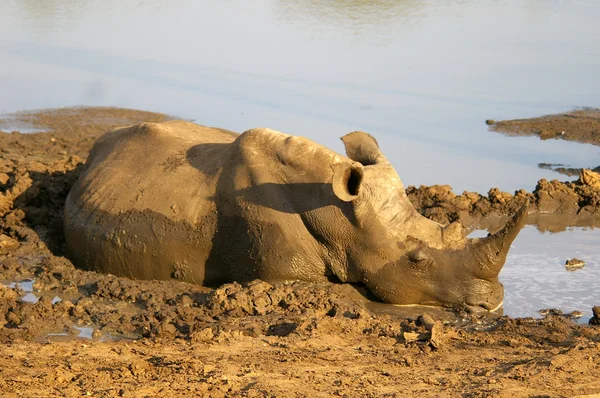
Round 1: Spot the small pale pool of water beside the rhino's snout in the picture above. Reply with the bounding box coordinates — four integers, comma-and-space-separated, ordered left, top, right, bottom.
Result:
500, 225, 600, 322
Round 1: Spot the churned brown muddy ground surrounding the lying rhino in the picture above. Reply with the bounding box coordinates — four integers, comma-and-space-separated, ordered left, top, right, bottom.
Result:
0, 108, 600, 397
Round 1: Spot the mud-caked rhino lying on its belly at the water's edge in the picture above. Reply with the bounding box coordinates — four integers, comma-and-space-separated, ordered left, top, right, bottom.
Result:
65, 121, 526, 310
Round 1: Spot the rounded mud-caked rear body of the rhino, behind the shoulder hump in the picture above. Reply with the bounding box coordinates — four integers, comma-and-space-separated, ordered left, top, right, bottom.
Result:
65, 121, 237, 284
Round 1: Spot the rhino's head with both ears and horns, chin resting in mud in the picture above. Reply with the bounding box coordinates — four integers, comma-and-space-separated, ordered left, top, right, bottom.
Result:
332, 132, 527, 310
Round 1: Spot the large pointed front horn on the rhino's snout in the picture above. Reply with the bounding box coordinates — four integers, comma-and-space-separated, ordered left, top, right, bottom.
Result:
474, 200, 529, 279
